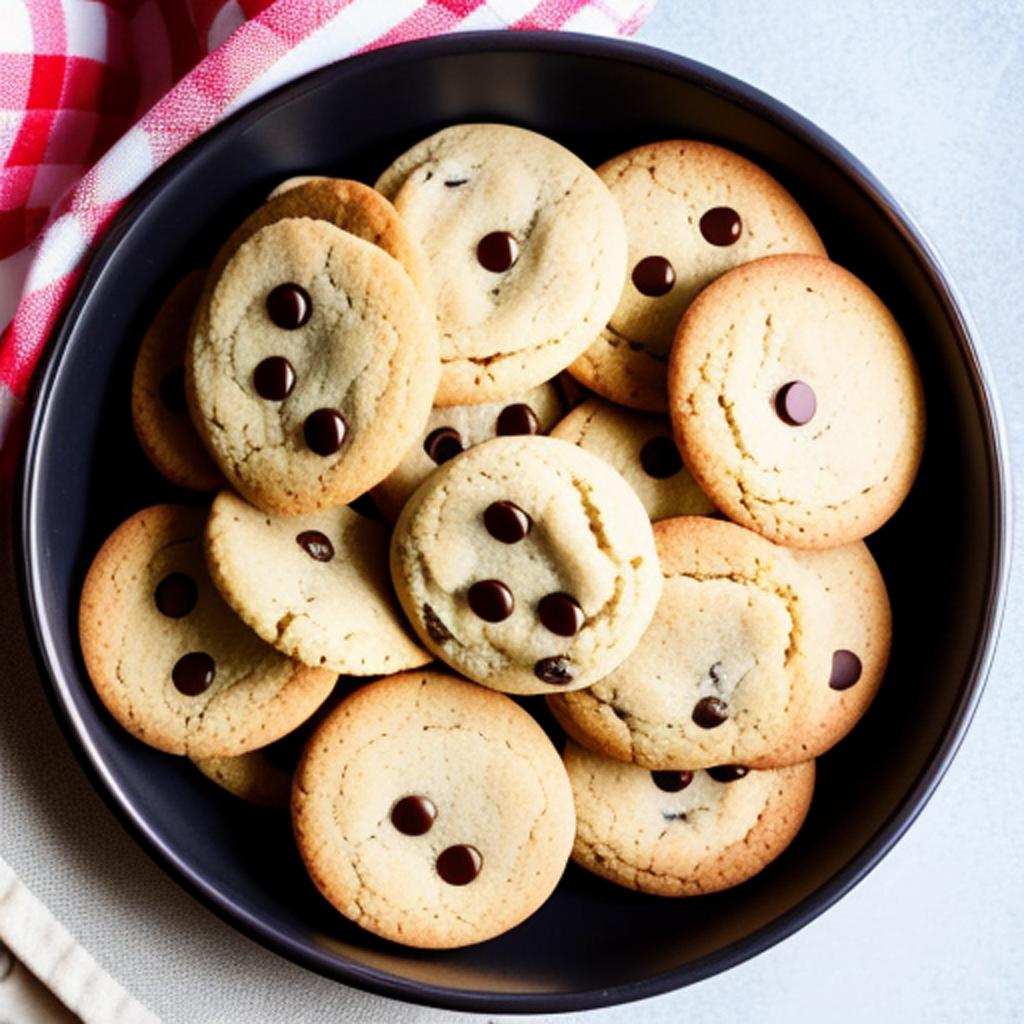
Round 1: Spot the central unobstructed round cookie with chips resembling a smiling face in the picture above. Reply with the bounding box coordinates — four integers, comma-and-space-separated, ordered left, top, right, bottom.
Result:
391, 436, 662, 693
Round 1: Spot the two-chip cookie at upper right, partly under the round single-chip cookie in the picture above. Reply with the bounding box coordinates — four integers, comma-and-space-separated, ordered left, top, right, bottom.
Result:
569, 140, 825, 412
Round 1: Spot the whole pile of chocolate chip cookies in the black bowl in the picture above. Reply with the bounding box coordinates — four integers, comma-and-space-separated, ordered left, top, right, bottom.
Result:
80, 125, 924, 948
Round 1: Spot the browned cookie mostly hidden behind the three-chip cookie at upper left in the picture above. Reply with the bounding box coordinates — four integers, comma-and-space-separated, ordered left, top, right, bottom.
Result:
210, 175, 432, 296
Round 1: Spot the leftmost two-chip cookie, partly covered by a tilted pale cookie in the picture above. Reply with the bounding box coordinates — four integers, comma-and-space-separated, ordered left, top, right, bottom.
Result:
79, 505, 336, 758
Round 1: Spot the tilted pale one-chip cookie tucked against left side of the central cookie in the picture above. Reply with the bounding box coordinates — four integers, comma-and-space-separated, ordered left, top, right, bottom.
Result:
206, 490, 433, 676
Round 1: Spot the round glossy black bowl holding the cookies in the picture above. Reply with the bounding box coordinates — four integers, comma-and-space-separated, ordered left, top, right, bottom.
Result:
18, 34, 1008, 1012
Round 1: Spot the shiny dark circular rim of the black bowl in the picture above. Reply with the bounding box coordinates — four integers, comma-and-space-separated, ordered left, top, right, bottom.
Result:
12, 32, 1011, 1014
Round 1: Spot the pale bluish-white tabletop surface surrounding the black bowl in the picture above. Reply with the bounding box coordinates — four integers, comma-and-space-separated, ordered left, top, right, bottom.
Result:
0, 0, 1024, 1024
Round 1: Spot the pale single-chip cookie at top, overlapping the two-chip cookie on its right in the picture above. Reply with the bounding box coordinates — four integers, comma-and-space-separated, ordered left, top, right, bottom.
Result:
377, 124, 626, 406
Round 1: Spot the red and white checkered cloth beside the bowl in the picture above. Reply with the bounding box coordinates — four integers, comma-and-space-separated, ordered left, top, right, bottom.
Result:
0, 0, 653, 469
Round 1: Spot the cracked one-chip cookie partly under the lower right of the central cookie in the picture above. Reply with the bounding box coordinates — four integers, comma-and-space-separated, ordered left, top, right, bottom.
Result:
548, 516, 833, 769
